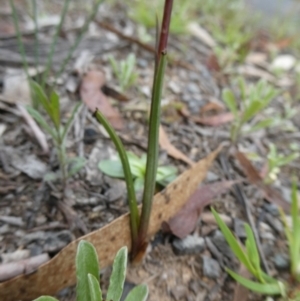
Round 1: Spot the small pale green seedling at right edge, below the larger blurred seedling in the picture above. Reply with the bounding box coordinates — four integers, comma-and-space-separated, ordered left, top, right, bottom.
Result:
265, 143, 300, 183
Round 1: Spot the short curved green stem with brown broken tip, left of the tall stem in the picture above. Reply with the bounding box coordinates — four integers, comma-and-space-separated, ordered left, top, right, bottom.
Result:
94, 109, 140, 247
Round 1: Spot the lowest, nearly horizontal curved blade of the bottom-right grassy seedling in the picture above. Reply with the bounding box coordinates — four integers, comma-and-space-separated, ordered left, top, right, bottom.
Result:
226, 269, 284, 295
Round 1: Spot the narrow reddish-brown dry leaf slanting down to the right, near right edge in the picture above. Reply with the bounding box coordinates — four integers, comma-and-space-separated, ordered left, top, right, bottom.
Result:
235, 151, 290, 211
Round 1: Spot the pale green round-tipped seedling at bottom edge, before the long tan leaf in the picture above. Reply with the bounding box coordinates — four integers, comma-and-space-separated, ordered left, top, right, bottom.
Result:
34, 240, 148, 301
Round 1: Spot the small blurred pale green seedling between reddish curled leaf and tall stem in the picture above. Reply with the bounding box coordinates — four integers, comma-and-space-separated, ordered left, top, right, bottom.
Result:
109, 53, 138, 92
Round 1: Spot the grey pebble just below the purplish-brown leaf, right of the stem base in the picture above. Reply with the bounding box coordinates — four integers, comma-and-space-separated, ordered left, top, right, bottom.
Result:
172, 235, 205, 255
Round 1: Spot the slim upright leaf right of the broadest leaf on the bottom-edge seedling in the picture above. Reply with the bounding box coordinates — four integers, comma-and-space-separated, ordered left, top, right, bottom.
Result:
106, 247, 127, 301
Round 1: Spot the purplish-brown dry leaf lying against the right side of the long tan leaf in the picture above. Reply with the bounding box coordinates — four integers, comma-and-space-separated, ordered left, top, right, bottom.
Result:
164, 181, 236, 239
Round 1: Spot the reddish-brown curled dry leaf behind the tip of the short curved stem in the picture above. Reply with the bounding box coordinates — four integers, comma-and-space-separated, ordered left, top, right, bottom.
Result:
80, 71, 123, 129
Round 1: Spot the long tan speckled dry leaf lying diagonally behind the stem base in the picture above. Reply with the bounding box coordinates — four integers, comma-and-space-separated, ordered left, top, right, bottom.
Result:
0, 147, 221, 301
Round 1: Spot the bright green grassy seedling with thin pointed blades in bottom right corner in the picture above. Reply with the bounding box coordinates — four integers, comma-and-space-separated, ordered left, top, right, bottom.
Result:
212, 182, 300, 301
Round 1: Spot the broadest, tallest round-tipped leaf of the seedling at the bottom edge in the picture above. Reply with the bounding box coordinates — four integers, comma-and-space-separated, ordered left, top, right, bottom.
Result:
76, 240, 99, 301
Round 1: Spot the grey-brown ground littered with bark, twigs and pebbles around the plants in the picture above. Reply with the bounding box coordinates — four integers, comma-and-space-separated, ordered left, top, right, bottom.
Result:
0, 1, 300, 301
